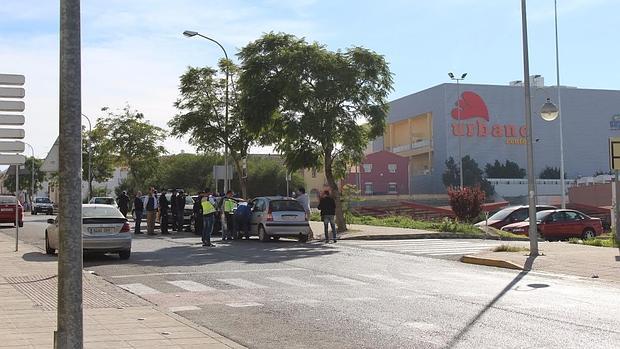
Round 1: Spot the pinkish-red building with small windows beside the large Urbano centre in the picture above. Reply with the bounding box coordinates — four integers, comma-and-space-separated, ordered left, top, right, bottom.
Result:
344, 150, 409, 195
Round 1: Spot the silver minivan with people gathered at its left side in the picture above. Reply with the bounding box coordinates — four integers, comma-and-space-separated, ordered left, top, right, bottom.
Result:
251, 196, 310, 242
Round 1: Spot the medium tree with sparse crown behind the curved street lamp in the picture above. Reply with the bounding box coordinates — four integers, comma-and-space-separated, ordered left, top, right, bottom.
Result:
168, 59, 255, 197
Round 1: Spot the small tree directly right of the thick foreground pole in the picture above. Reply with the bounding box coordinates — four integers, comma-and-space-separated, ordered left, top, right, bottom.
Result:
82, 124, 114, 196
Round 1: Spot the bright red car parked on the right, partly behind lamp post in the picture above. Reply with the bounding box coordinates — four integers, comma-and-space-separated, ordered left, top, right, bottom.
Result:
502, 210, 603, 240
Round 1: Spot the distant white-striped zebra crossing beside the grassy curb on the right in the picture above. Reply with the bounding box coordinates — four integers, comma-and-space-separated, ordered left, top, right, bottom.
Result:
343, 239, 499, 257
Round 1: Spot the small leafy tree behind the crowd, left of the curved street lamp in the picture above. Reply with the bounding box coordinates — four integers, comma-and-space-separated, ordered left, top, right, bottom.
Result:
97, 106, 166, 189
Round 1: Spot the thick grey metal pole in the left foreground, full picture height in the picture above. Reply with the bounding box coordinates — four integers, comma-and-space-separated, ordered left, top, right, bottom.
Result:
54, 0, 84, 349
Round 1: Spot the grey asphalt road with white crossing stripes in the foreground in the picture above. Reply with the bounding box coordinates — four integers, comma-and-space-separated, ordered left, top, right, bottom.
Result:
6, 216, 620, 348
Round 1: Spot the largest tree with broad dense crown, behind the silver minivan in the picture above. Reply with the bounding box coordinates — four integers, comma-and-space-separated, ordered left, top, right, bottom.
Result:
239, 33, 392, 231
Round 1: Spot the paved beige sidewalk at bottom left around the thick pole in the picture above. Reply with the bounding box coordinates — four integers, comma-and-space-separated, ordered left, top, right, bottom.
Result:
0, 234, 243, 349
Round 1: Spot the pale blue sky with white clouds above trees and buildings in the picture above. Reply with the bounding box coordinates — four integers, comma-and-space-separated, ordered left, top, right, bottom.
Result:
0, 0, 620, 158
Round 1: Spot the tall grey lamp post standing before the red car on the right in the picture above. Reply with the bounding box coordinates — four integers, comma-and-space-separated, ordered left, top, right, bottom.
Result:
521, 0, 538, 256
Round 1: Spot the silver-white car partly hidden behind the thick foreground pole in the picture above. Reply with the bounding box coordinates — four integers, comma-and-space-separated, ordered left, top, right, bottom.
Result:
45, 204, 133, 259
